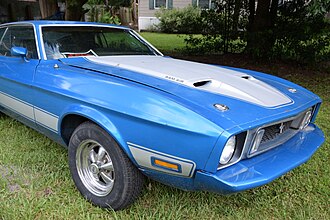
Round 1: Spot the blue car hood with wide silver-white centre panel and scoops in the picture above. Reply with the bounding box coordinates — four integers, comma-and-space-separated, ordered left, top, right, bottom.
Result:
61, 56, 320, 131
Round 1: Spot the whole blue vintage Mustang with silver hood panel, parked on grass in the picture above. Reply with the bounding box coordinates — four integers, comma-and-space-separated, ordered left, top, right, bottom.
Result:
0, 21, 324, 210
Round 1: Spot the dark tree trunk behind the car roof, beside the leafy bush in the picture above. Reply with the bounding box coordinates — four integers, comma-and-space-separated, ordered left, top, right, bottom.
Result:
65, 0, 88, 21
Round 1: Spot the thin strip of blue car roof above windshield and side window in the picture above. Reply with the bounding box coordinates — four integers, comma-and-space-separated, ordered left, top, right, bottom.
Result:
0, 20, 128, 29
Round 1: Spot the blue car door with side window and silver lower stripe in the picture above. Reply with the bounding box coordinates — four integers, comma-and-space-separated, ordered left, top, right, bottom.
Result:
0, 24, 39, 125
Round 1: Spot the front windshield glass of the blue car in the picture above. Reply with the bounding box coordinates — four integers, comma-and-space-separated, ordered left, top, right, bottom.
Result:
42, 26, 159, 59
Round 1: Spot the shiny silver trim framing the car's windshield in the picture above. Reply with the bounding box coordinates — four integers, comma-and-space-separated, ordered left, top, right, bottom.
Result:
39, 24, 164, 60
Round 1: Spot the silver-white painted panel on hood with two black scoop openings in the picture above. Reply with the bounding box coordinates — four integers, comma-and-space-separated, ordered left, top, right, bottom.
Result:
85, 56, 292, 108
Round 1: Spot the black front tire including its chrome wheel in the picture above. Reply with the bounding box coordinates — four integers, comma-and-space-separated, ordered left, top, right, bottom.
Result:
68, 122, 144, 210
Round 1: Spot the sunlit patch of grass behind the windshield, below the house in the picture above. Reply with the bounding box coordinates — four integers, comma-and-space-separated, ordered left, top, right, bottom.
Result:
140, 32, 186, 54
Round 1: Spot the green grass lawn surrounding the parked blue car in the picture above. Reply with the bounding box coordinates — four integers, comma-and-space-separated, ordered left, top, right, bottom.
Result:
0, 33, 330, 220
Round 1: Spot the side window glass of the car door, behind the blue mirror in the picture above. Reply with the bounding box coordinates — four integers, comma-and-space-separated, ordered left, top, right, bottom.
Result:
0, 26, 38, 59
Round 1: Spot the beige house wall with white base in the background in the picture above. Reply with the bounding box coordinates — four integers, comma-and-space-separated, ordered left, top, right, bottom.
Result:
138, 0, 192, 31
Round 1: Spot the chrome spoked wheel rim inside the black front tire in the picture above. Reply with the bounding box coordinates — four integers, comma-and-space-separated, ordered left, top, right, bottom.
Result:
76, 140, 115, 197
